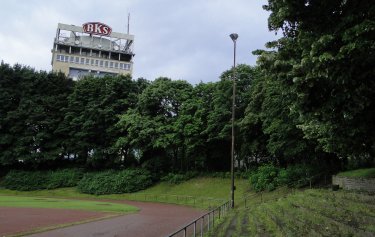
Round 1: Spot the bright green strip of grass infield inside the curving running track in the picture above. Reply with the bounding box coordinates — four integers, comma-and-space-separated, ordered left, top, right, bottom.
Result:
0, 196, 138, 213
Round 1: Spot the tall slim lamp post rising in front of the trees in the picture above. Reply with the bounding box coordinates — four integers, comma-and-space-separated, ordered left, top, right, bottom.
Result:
229, 33, 238, 208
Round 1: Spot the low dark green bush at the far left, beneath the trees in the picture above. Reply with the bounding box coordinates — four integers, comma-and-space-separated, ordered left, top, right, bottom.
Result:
1, 169, 83, 191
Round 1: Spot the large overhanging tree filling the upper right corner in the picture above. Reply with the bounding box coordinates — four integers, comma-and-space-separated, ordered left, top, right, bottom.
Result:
265, 0, 375, 163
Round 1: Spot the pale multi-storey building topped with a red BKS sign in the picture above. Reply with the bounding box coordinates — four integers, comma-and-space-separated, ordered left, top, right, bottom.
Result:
51, 22, 134, 80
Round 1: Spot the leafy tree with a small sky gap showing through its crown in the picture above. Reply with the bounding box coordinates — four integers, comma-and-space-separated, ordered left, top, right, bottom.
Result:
118, 78, 192, 172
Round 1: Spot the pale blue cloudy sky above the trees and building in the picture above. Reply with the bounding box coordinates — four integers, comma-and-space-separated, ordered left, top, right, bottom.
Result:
0, 0, 277, 84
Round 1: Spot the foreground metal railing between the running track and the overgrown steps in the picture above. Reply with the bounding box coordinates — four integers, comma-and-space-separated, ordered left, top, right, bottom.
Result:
167, 201, 230, 237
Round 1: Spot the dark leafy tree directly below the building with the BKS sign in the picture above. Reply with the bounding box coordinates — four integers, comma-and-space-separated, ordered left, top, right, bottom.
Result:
60, 76, 139, 168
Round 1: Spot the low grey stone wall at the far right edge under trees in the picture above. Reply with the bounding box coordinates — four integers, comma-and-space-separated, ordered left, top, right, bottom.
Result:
332, 175, 375, 193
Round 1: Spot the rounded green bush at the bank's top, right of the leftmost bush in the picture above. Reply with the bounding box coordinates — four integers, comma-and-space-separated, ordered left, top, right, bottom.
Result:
77, 169, 152, 195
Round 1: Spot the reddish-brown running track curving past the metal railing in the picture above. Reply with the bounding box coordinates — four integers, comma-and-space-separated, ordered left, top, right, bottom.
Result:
6, 201, 204, 237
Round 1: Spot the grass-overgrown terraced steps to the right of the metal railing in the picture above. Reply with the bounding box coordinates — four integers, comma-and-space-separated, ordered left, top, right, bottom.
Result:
211, 189, 375, 237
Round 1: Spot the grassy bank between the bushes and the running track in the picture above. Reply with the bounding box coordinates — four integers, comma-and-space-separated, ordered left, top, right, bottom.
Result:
0, 177, 253, 208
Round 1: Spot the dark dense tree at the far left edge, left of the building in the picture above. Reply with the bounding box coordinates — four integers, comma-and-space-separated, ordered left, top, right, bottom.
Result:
0, 63, 73, 166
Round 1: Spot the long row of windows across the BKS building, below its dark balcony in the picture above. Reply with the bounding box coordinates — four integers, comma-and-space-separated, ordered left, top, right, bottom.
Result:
56, 54, 130, 71
